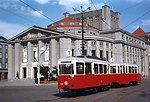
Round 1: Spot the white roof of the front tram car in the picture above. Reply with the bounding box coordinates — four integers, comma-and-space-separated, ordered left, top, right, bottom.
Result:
59, 57, 109, 64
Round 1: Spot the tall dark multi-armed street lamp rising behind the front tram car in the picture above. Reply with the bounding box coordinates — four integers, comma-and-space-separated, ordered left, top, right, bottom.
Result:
73, 5, 91, 56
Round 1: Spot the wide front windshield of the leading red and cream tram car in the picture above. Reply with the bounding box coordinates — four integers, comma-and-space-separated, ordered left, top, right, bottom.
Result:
59, 64, 74, 74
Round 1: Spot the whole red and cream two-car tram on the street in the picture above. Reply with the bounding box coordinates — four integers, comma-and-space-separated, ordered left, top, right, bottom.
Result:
58, 57, 141, 91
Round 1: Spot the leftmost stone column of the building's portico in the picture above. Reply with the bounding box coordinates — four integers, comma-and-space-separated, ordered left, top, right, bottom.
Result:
8, 44, 15, 80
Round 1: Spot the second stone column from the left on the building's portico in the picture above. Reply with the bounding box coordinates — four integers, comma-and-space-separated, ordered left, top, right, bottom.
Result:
15, 43, 20, 78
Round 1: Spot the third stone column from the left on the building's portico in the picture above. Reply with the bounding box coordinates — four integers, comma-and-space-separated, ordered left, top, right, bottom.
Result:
27, 42, 32, 79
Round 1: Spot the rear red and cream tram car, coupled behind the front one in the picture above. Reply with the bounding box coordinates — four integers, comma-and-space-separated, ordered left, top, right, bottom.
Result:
110, 63, 141, 85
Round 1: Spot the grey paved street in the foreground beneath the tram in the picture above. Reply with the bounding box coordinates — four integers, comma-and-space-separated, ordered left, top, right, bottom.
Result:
0, 79, 150, 102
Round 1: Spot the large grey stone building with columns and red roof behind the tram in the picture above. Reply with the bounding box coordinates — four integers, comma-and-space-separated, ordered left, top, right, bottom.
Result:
8, 5, 149, 79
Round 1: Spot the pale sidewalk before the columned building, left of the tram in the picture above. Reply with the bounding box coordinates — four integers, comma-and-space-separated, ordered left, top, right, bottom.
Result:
0, 80, 57, 87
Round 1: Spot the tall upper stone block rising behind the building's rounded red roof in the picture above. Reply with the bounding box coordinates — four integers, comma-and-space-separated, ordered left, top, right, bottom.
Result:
69, 5, 120, 30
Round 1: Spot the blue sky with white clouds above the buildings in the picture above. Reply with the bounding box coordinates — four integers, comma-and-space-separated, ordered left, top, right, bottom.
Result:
0, 0, 150, 39
